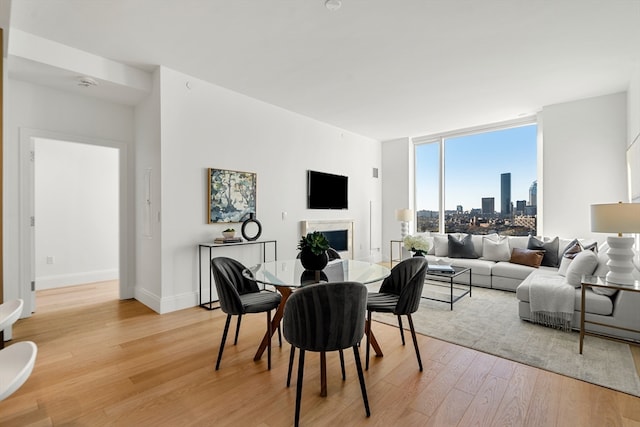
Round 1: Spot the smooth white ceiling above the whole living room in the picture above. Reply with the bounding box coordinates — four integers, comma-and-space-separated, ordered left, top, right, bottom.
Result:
5, 0, 640, 140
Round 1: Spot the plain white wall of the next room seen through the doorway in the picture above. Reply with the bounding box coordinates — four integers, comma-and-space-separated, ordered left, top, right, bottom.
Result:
35, 138, 120, 290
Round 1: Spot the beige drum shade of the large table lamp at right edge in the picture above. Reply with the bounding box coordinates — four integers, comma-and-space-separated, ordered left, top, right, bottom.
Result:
591, 202, 640, 234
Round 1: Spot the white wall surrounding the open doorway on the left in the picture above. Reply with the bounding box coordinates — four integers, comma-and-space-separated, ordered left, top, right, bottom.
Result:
3, 78, 135, 314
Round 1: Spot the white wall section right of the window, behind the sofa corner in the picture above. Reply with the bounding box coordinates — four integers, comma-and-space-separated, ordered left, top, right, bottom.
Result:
541, 93, 628, 240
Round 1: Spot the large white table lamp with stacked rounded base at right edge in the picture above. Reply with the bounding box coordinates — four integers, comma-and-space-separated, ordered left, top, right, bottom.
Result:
591, 202, 640, 285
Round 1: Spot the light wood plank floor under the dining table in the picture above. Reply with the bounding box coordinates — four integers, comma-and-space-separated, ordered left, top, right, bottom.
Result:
0, 284, 640, 427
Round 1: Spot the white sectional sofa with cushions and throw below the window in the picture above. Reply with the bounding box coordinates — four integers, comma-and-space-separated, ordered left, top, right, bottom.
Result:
416, 233, 640, 342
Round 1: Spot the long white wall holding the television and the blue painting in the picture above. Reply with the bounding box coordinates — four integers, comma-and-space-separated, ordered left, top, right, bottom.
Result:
136, 67, 381, 313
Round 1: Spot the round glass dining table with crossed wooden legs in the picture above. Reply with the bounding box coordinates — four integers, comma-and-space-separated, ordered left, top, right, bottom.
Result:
242, 259, 391, 396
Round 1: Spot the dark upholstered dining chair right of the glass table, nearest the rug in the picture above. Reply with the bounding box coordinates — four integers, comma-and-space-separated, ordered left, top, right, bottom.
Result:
366, 257, 428, 372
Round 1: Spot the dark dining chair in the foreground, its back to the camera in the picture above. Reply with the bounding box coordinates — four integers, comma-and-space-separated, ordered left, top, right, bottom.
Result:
283, 282, 371, 426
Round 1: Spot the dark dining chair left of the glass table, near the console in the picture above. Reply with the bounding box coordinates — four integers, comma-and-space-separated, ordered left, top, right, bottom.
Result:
211, 257, 282, 371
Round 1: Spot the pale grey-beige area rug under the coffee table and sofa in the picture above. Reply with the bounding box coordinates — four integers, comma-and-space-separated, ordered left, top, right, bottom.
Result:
373, 288, 640, 396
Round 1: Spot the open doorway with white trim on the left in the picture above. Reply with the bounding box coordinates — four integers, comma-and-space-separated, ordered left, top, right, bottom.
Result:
19, 128, 135, 316
